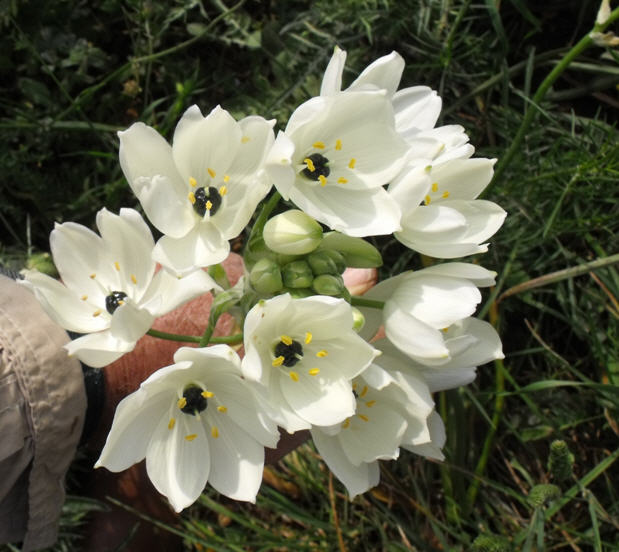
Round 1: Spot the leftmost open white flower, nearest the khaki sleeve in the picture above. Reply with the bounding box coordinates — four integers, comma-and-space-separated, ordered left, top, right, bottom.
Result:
22, 209, 215, 367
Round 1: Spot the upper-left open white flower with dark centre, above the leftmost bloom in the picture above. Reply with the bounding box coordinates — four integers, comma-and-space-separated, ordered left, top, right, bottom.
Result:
119, 105, 274, 274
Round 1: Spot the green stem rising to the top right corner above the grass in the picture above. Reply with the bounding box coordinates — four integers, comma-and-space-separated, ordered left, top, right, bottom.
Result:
485, 4, 619, 193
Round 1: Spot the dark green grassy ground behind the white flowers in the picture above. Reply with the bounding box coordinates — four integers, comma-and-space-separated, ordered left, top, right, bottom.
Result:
0, 0, 619, 551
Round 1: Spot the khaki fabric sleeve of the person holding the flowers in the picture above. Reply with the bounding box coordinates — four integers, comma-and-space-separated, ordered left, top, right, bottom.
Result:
0, 275, 86, 551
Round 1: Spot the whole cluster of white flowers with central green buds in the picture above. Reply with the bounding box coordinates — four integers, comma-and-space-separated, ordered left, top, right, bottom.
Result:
23, 48, 505, 511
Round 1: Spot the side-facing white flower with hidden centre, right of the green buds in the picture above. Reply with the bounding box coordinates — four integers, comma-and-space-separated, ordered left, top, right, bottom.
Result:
360, 263, 496, 365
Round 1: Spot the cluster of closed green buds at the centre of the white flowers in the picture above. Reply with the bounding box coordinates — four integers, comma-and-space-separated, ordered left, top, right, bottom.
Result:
249, 209, 382, 301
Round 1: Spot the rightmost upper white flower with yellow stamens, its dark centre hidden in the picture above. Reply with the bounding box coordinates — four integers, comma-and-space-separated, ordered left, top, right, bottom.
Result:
389, 159, 506, 259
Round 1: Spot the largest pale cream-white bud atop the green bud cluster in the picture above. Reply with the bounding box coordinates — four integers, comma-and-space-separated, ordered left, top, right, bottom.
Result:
262, 209, 322, 255
